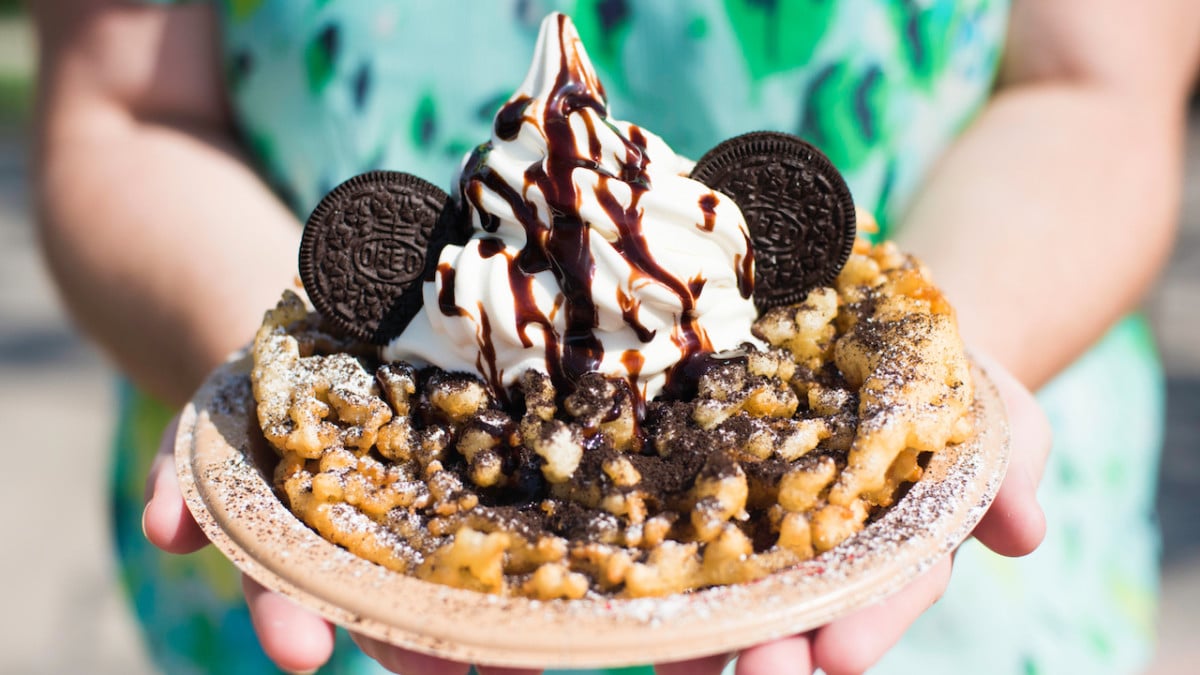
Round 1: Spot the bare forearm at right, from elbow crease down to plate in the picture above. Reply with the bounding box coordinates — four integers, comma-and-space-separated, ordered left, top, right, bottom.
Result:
901, 84, 1184, 388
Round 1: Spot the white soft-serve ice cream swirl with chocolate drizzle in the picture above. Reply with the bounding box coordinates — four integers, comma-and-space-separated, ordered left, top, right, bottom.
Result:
383, 14, 756, 399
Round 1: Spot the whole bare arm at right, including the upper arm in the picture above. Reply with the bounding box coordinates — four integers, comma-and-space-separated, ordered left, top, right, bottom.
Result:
901, 0, 1200, 388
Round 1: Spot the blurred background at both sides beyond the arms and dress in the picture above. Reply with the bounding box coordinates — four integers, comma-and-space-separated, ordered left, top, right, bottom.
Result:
0, 5, 1200, 675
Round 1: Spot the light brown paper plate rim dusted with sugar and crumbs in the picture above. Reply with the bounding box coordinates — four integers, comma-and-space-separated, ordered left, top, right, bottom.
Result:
175, 356, 1008, 668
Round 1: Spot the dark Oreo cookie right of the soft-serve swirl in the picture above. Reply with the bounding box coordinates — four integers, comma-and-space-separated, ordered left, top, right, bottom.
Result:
691, 131, 854, 311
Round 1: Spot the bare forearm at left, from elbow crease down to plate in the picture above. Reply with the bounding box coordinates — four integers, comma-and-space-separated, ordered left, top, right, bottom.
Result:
38, 110, 300, 404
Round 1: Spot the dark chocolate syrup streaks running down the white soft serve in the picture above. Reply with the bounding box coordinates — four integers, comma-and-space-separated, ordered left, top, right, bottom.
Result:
438, 17, 715, 408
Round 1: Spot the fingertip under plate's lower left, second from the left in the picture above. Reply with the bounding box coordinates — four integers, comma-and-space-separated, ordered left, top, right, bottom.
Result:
241, 575, 334, 673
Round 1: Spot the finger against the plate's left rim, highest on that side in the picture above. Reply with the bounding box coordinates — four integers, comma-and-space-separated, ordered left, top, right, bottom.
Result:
142, 416, 209, 554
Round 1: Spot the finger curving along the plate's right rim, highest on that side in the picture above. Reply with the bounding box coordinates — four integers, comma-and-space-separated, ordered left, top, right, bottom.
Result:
974, 358, 1052, 556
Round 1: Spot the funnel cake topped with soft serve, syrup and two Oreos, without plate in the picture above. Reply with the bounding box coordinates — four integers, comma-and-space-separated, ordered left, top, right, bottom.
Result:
243, 14, 976, 599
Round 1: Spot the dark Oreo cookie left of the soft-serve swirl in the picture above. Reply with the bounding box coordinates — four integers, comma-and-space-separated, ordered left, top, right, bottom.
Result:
300, 171, 469, 345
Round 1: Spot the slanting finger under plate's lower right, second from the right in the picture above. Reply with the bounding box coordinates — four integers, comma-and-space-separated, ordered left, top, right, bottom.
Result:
812, 556, 952, 675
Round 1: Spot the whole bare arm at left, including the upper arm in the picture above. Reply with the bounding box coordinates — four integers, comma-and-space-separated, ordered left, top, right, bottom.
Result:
32, 0, 300, 404
